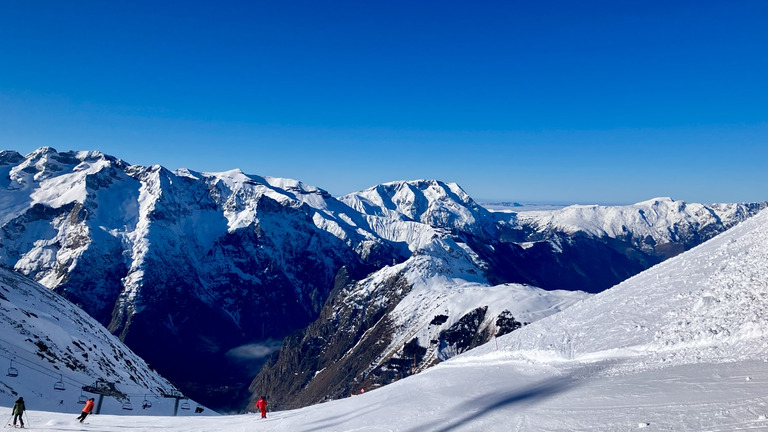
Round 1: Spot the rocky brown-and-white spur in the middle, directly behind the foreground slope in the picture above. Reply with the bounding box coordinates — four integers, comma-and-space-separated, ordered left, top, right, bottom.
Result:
251, 239, 589, 409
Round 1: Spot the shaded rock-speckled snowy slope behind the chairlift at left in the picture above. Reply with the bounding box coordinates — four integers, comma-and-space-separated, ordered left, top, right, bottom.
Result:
0, 269, 200, 415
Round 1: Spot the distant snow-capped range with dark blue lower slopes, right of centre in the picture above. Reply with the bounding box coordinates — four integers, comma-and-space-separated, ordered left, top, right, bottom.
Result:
340, 180, 766, 293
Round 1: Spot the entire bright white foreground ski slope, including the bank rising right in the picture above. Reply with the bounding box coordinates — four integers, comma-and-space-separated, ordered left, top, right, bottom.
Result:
0, 207, 768, 432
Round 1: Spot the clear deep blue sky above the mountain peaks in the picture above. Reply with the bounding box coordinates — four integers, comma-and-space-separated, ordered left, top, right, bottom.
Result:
0, 0, 768, 203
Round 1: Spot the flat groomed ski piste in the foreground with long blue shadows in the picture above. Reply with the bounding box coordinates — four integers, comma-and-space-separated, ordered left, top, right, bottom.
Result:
0, 359, 768, 432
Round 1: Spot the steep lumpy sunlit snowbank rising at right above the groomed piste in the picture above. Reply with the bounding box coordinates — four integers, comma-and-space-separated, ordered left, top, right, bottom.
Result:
464, 207, 768, 368
